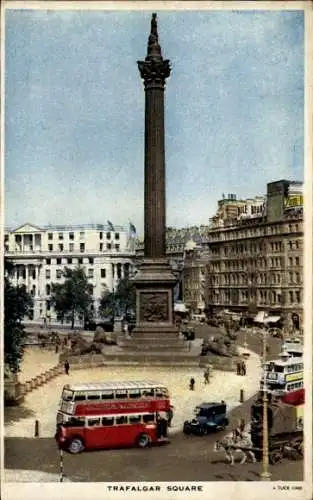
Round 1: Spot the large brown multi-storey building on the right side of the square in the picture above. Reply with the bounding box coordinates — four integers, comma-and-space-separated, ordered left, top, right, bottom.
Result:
205, 180, 303, 330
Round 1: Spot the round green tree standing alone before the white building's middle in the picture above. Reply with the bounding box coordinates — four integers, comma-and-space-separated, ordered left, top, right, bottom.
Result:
51, 266, 93, 329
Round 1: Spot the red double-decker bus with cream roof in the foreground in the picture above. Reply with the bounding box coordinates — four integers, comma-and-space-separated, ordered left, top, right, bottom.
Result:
56, 381, 171, 453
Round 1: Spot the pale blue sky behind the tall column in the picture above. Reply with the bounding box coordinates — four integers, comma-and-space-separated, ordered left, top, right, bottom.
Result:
4, 10, 304, 234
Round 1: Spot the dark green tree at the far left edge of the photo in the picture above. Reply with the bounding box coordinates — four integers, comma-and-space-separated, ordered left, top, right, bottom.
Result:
4, 272, 33, 373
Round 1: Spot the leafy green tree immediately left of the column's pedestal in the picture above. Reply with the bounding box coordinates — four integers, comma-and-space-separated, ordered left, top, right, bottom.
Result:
99, 278, 136, 317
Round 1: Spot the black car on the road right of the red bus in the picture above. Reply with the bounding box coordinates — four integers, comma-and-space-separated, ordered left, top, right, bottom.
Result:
183, 401, 229, 436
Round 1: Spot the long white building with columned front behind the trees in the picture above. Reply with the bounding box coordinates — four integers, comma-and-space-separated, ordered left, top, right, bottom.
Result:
4, 224, 135, 321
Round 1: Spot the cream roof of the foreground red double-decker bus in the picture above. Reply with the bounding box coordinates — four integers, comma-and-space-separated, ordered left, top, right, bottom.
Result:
63, 380, 166, 392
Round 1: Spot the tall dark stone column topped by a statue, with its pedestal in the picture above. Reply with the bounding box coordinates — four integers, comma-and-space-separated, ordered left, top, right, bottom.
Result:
124, 14, 195, 365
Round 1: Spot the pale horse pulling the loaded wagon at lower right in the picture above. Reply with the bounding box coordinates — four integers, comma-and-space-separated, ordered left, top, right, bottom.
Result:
213, 429, 256, 465
